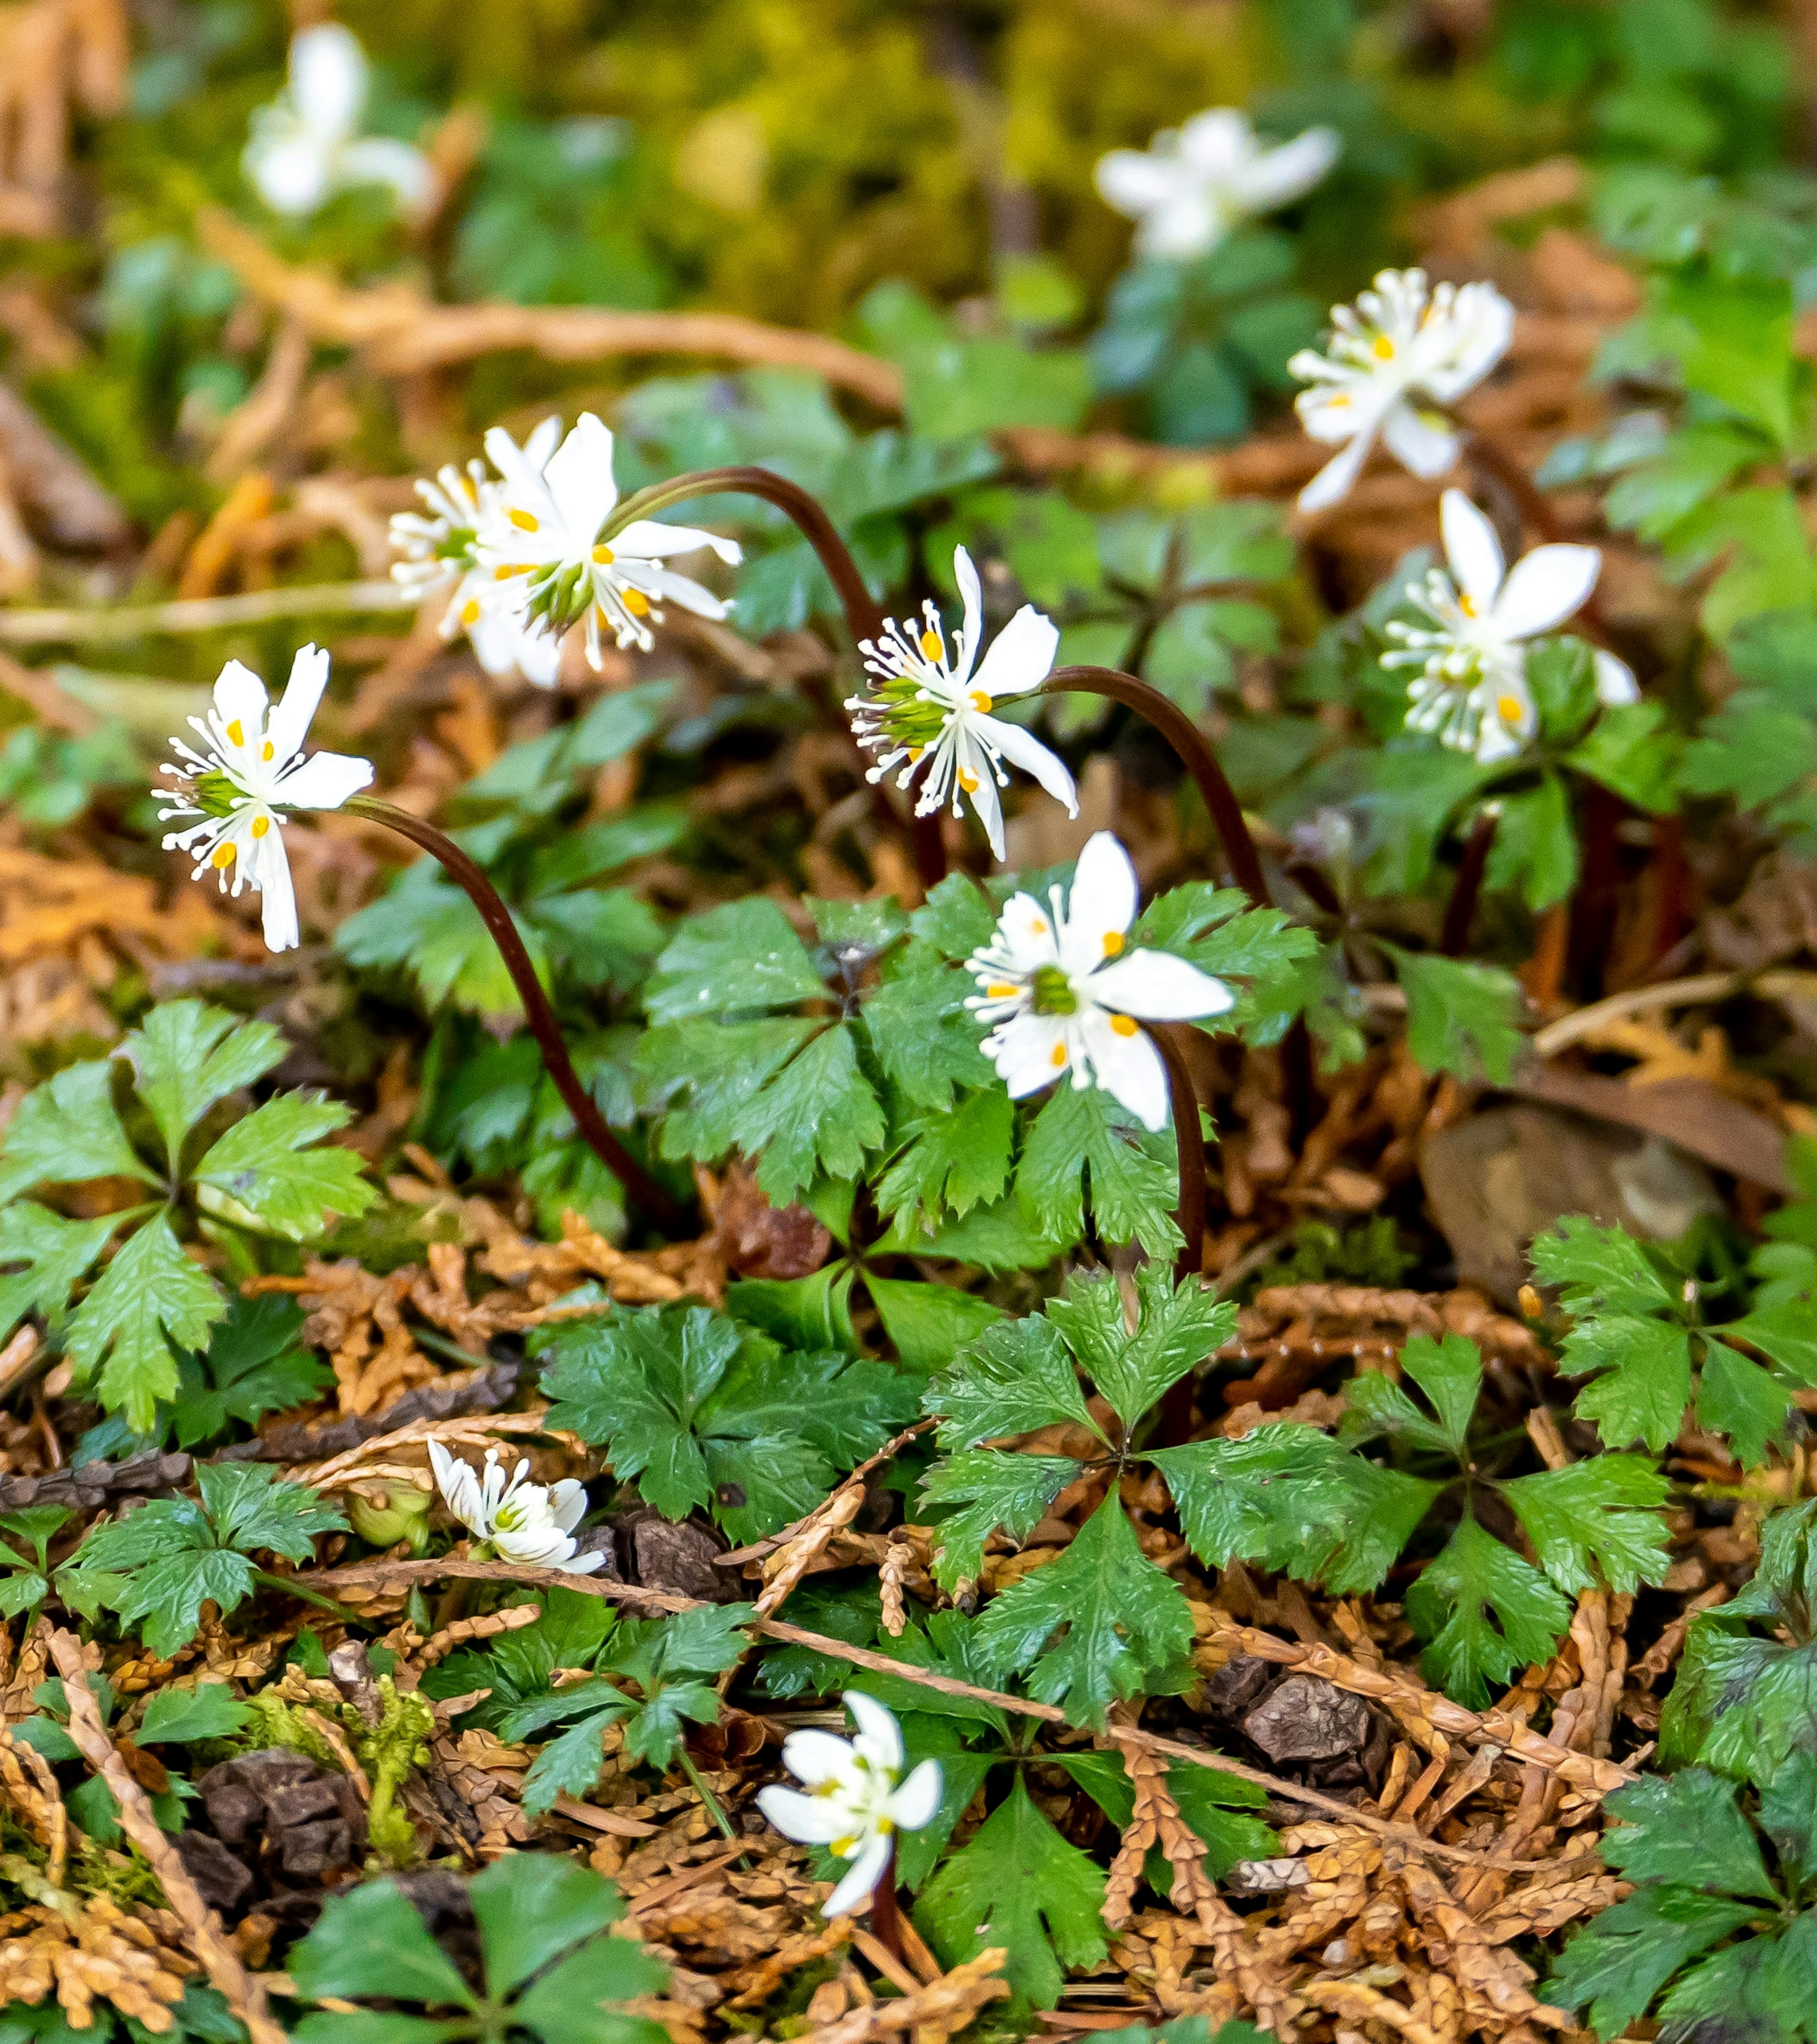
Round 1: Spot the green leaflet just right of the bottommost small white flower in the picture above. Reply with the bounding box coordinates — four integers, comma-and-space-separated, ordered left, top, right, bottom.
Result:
916, 1774, 1108, 2009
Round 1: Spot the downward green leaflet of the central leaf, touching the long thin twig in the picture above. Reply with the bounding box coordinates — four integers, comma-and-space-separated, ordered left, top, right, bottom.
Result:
979, 1488, 1191, 1727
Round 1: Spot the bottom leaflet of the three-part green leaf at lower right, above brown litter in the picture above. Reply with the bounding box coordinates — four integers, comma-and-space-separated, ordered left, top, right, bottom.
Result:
1406, 1519, 1572, 1711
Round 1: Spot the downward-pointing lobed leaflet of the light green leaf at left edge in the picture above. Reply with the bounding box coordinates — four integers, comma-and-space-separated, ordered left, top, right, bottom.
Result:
68, 1214, 227, 1433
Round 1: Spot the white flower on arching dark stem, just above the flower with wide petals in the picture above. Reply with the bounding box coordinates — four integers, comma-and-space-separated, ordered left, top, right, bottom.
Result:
846, 546, 1079, 858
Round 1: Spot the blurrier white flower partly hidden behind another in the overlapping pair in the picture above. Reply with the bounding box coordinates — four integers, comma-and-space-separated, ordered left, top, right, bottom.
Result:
390, 419, 562, 689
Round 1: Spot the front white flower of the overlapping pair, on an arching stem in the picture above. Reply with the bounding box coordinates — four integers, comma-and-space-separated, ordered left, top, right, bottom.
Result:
474, 411, 744, 666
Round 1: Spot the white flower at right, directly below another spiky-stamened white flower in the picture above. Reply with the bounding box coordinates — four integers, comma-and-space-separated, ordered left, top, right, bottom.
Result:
1382, 491, 1639, 767
